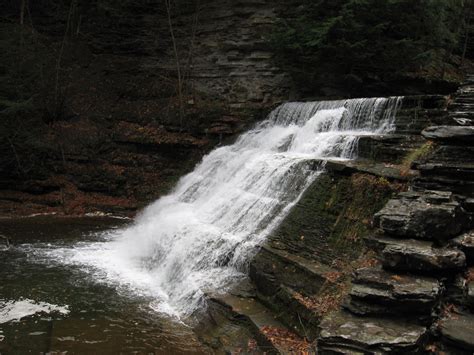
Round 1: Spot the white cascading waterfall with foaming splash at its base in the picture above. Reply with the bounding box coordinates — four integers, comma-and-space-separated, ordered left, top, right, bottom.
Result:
30, 98, 401, 317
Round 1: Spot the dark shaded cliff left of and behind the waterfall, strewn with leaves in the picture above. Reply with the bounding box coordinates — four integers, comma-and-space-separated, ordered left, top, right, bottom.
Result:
0, 1, 290, 214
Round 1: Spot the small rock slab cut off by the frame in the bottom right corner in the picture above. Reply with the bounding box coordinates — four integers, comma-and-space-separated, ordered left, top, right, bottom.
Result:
439, 314, 474, 351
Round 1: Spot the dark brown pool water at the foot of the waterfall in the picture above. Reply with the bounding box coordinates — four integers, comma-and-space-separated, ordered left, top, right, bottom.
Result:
0, 217, 211, 354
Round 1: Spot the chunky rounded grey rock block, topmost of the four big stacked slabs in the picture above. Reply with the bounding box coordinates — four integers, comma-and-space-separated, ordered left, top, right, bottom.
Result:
374, 190, 469, 240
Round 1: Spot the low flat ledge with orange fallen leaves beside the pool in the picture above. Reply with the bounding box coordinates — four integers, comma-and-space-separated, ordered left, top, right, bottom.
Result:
208, 294, 314, 354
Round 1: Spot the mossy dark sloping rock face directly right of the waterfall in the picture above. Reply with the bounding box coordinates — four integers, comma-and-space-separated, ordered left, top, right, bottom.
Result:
270, 172, 403, 264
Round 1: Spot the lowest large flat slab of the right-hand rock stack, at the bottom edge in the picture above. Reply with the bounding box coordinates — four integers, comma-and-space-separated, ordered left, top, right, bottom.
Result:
318, 311, 426, 354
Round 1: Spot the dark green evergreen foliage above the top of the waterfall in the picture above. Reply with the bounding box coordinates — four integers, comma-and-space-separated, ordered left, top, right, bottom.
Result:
271, 0, 465, 90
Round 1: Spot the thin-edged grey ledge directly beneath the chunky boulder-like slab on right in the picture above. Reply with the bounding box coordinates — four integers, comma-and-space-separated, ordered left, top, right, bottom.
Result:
366, 236, 466, 276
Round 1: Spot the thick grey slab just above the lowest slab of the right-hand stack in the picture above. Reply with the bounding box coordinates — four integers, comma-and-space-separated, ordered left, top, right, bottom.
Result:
345, 267, 441, 319
